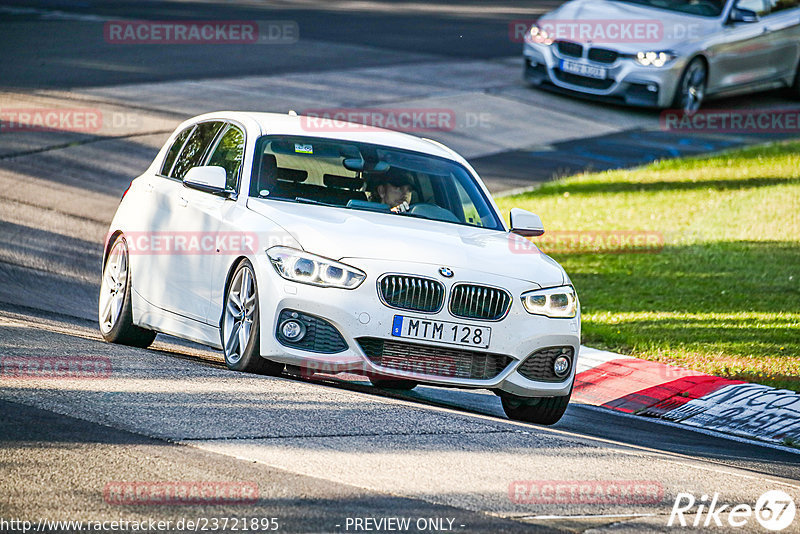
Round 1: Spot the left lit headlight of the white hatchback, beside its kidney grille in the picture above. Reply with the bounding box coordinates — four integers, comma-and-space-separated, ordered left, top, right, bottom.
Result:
267, 247, 367, 289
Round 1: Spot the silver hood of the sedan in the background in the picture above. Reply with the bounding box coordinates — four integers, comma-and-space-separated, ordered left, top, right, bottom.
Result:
539, 0, 720, 53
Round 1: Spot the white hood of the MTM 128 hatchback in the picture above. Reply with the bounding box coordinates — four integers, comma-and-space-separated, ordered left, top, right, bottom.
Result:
247, 198, 566, 287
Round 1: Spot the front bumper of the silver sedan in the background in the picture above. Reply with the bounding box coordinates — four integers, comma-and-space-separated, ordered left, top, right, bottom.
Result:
523, 43, 685, 108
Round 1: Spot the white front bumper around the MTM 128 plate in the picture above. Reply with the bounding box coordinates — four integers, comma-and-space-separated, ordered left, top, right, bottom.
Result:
256, 257, 580, 397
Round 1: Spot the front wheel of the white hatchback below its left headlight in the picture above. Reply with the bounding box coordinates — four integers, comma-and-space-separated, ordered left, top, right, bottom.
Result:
220, 260, 284, 375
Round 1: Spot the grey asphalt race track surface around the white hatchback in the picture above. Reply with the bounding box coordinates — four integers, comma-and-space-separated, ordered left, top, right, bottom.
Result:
0, 0, 800, 532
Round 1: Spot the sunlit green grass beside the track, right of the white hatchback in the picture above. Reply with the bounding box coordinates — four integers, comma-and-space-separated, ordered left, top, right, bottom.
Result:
497, 142, 800, 391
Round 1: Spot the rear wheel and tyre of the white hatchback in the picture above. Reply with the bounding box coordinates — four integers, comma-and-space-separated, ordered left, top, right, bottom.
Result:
97, 236, 156, 348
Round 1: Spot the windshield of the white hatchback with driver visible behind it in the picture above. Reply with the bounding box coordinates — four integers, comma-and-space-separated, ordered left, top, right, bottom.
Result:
250, 136, 503, 230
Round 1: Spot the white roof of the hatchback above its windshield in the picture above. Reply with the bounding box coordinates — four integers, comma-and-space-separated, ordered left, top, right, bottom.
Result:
182, 111, 465, 163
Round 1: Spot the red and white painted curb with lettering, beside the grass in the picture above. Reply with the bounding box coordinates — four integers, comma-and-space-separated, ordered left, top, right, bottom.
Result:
572, 347, 800, 445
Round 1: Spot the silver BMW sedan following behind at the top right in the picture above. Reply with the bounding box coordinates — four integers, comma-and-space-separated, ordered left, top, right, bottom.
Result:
524, 0, 800, 112
